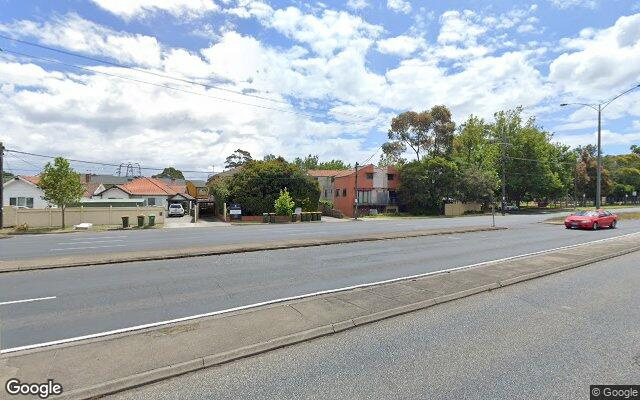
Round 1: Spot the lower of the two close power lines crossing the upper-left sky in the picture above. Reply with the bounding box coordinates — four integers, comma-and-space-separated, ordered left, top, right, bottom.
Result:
0, 44, 373, 126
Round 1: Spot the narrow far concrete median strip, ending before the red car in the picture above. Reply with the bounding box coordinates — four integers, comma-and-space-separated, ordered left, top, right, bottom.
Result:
0, 227, 507, 273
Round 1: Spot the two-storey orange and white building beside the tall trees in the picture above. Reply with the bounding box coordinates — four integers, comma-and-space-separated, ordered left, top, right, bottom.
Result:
312, 164, 399, 217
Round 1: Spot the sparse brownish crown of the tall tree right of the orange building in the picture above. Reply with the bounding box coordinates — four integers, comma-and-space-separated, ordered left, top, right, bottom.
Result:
383, 106, 455, 161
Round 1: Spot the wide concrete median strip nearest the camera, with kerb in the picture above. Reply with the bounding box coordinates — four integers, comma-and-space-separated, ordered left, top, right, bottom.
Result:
5, 233, 640, 399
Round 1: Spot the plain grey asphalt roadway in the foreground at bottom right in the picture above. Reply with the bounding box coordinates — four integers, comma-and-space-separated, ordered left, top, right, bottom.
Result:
109, 253, 640, 400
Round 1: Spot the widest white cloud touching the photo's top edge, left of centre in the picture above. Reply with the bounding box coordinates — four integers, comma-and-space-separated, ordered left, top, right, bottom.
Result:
91, 0, 220, 20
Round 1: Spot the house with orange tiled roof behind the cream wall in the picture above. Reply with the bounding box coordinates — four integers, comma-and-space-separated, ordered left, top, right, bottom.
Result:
93, 176, 195, 210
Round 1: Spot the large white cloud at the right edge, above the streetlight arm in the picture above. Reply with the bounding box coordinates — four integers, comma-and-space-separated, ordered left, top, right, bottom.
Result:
549, 14, 640, 101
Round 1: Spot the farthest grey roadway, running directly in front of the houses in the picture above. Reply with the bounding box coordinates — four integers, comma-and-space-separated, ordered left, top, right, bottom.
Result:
0, 208, 640, 260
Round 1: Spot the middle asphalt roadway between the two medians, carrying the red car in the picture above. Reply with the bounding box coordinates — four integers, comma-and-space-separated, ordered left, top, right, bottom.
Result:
0, 216, 640, 349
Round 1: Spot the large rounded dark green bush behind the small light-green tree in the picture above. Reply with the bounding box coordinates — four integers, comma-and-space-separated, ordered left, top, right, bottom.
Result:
222, 158, 320, 215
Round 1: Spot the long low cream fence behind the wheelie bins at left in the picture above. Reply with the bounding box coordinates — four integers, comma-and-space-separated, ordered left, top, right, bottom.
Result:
2, 206, 165, 228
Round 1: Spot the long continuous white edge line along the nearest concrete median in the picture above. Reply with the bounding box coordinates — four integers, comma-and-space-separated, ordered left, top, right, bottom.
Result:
0, 232, 640, 354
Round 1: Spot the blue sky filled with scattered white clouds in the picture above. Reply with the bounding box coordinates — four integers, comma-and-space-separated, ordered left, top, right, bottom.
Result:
0, 0, 640, 177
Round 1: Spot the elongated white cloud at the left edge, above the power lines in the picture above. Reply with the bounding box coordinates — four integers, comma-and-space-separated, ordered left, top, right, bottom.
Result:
0, 13, 162, 66
